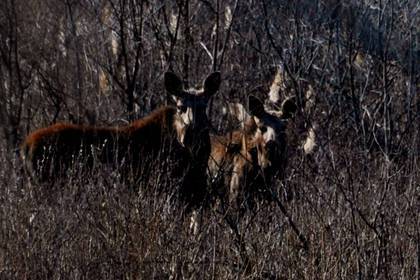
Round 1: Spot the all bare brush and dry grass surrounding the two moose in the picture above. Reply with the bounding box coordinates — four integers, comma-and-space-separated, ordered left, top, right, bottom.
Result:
0, 0, 420, 279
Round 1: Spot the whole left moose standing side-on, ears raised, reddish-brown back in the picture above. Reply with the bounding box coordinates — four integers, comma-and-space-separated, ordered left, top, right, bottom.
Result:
21, 72, 221, 208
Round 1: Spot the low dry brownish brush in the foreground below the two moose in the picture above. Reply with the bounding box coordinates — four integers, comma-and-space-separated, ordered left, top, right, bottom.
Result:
0, 133, 419, 279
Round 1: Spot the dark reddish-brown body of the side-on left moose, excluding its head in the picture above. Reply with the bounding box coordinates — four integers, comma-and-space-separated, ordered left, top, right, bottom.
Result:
22, 107, 182, 182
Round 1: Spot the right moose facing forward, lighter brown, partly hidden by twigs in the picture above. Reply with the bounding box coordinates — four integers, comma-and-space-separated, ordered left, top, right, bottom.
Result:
209, 95, 296, 210
